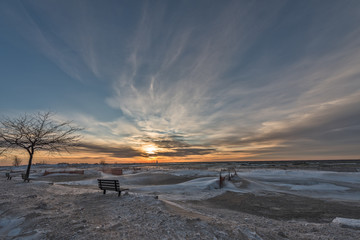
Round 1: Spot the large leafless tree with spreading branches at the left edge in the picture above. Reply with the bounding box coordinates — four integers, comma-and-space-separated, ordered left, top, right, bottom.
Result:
0, 112, 81, 178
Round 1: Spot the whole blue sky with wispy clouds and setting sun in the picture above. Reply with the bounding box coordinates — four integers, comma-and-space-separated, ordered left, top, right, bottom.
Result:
0, 0, 360, 163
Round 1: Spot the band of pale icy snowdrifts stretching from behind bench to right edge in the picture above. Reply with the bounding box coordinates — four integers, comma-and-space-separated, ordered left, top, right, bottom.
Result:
52, 169, 360, 201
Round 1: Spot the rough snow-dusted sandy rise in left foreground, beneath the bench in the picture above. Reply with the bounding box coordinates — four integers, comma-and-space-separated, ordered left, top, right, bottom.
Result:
0, 181, 247, 239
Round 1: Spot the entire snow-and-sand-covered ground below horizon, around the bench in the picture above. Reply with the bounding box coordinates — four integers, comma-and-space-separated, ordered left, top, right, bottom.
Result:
0, 165, 360, 239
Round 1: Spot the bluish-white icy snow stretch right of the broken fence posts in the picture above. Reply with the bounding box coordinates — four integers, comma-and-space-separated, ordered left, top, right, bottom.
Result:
237, 169, 360, 201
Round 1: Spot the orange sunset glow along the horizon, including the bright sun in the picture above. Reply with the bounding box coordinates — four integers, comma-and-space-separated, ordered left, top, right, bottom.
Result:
0, 144, 358, 166
